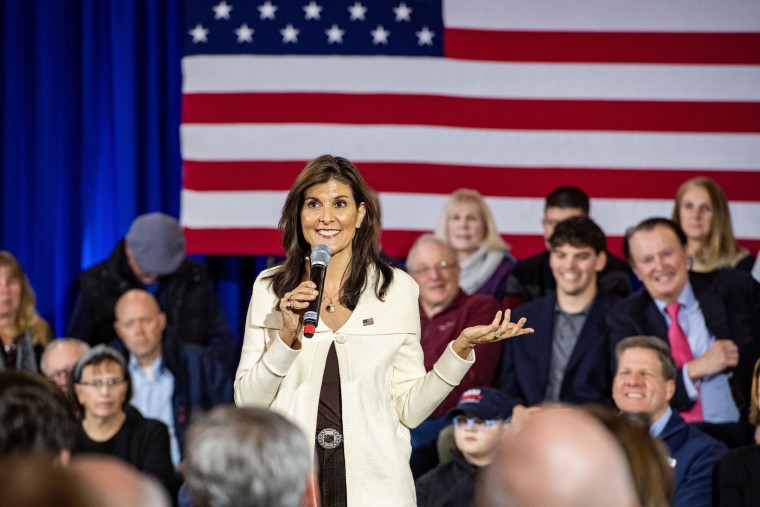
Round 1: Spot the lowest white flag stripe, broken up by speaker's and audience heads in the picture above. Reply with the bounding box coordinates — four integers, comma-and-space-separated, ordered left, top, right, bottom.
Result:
181, 190, 760, 239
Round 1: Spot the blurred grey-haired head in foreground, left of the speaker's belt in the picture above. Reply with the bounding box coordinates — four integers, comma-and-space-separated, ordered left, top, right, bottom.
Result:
186, 405, 319, 507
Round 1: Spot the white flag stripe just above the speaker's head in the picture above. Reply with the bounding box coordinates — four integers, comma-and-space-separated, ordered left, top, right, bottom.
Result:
181, 124, 760, 170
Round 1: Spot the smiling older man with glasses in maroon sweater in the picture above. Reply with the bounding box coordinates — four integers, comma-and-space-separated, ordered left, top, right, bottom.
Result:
407, 234, 501, 477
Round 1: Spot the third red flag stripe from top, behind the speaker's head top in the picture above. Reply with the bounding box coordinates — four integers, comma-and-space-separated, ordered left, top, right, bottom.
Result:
183, 160, 760, 201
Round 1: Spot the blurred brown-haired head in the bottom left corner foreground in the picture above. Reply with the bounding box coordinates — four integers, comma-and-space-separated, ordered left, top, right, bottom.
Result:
0, 453, 98, 507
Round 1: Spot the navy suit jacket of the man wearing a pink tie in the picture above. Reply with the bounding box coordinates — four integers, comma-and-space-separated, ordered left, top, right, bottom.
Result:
607, 269, 760, 420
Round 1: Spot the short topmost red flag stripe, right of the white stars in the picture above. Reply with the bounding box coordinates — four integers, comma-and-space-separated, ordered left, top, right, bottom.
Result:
444, 28, 760, 65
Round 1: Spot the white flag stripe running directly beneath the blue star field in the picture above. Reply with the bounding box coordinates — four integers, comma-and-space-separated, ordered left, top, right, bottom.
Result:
182, 56, 760, 102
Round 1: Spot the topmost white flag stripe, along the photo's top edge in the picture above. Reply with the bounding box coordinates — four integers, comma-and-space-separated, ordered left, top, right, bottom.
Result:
443, 0, 760, 32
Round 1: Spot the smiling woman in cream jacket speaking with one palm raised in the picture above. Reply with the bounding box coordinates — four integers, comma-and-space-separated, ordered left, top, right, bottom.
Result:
235, 155, 533, 506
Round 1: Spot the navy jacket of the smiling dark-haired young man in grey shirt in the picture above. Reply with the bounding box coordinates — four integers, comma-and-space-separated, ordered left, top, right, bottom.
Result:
497, 291, 616, 405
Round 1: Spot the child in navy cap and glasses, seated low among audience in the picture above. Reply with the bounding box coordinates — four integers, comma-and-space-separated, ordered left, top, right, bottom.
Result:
415, 387, 514, 507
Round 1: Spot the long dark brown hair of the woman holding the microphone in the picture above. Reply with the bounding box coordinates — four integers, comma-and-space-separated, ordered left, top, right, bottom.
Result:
267, 155, 393, 310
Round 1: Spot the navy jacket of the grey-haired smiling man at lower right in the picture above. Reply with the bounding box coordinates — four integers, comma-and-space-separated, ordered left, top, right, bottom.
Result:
660, 412, 727, 507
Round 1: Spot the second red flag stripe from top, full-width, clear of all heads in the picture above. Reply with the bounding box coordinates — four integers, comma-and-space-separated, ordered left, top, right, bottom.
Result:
182, 93, 760, 133
